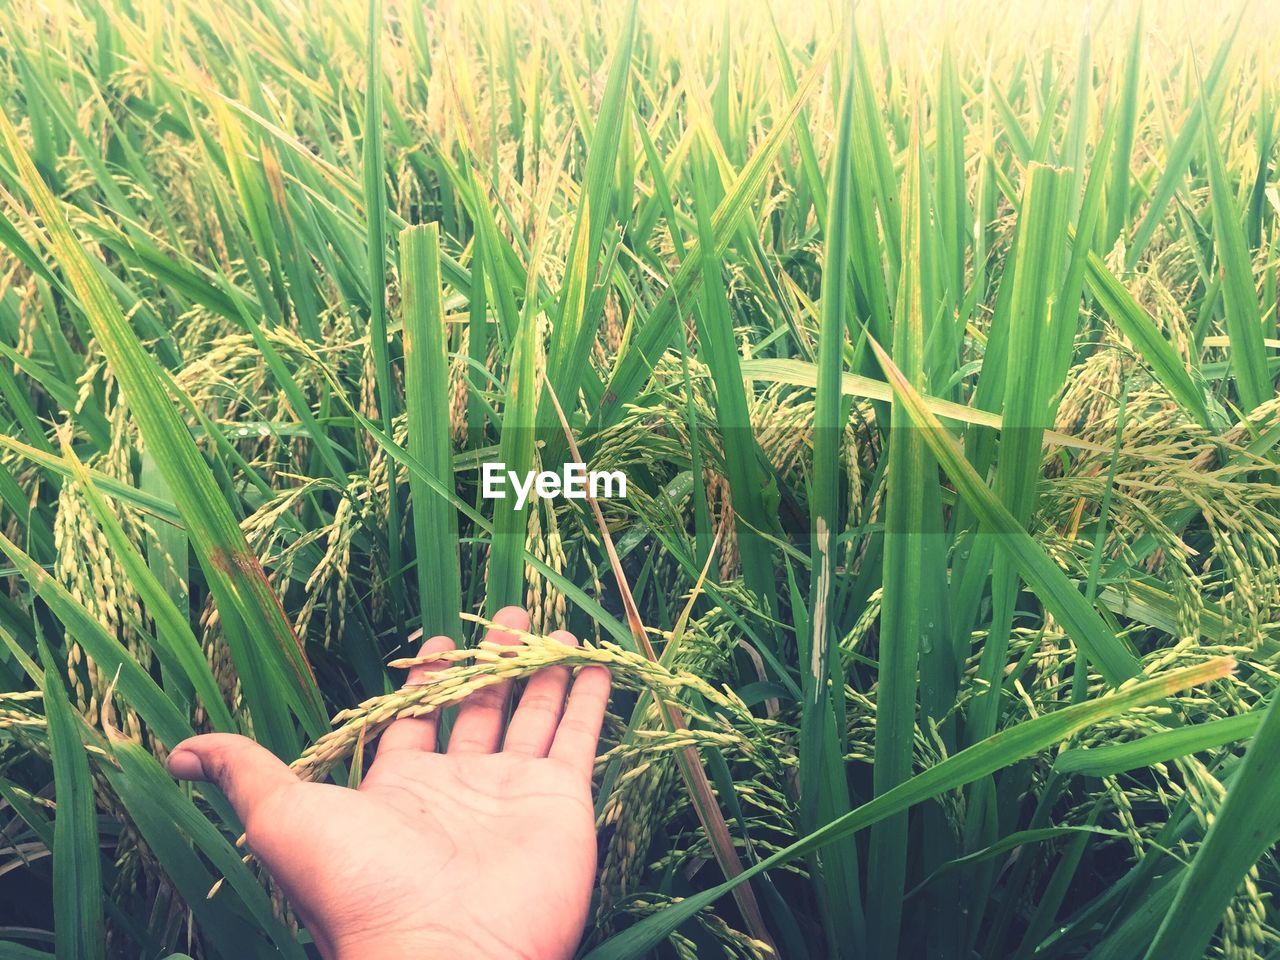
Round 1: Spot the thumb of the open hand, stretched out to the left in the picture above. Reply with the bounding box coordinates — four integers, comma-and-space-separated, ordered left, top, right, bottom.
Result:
165, 733, 300, 827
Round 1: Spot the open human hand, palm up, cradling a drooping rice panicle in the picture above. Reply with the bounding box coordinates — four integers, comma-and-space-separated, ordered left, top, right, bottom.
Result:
168, 607, 609, 960
